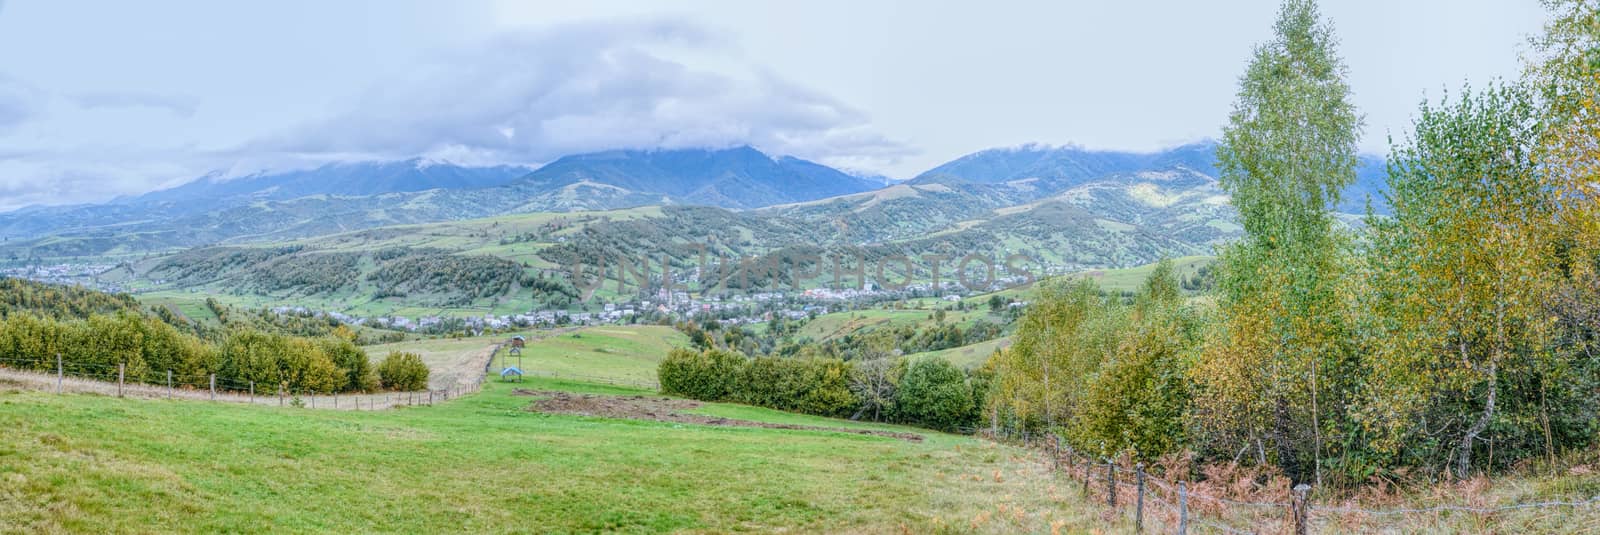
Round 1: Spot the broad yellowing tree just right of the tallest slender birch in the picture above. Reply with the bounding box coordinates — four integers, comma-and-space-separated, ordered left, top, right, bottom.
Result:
1358, 86, 1568, 477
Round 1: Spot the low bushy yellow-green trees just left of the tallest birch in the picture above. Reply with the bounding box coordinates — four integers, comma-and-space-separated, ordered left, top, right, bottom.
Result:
974, 259, 1200, 460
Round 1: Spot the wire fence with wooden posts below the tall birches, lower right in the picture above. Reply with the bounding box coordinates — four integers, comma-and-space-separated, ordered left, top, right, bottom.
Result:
1029, 437, 1600, 533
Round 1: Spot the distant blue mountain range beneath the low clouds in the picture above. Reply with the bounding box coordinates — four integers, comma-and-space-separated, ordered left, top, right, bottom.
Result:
0, 143, 1382, 261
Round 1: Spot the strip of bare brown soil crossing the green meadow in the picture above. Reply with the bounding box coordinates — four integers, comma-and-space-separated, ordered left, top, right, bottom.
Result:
512, 388, 922, 442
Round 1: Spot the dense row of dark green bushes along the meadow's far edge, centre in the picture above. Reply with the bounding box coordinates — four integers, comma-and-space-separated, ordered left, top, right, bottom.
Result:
658, 348, 987, 431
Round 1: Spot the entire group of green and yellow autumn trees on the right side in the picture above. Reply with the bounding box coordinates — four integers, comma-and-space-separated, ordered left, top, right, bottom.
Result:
972, 0, 1600, 482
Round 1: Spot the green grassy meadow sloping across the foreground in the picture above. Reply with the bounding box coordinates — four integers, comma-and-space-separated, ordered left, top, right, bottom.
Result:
0, 380, 1099, 533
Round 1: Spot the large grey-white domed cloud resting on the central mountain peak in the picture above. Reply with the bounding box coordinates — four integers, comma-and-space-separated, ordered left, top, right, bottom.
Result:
242, 19, 910, 165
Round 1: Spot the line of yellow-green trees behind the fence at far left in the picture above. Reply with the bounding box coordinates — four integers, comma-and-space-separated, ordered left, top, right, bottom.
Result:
0, 279, 427, 394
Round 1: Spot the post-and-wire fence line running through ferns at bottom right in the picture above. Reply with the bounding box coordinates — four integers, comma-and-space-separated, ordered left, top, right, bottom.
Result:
1027, 437, 1600, 533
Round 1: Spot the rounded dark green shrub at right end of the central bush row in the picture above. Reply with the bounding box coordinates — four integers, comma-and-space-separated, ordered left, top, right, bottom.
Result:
894, 357, 978, 431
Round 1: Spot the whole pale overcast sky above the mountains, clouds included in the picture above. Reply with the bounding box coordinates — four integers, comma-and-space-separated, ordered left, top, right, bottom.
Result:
0, 0, 1544, 210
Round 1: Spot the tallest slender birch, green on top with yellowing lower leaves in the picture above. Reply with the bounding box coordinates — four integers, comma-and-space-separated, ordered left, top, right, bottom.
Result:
1192, 0, 1362, 481
